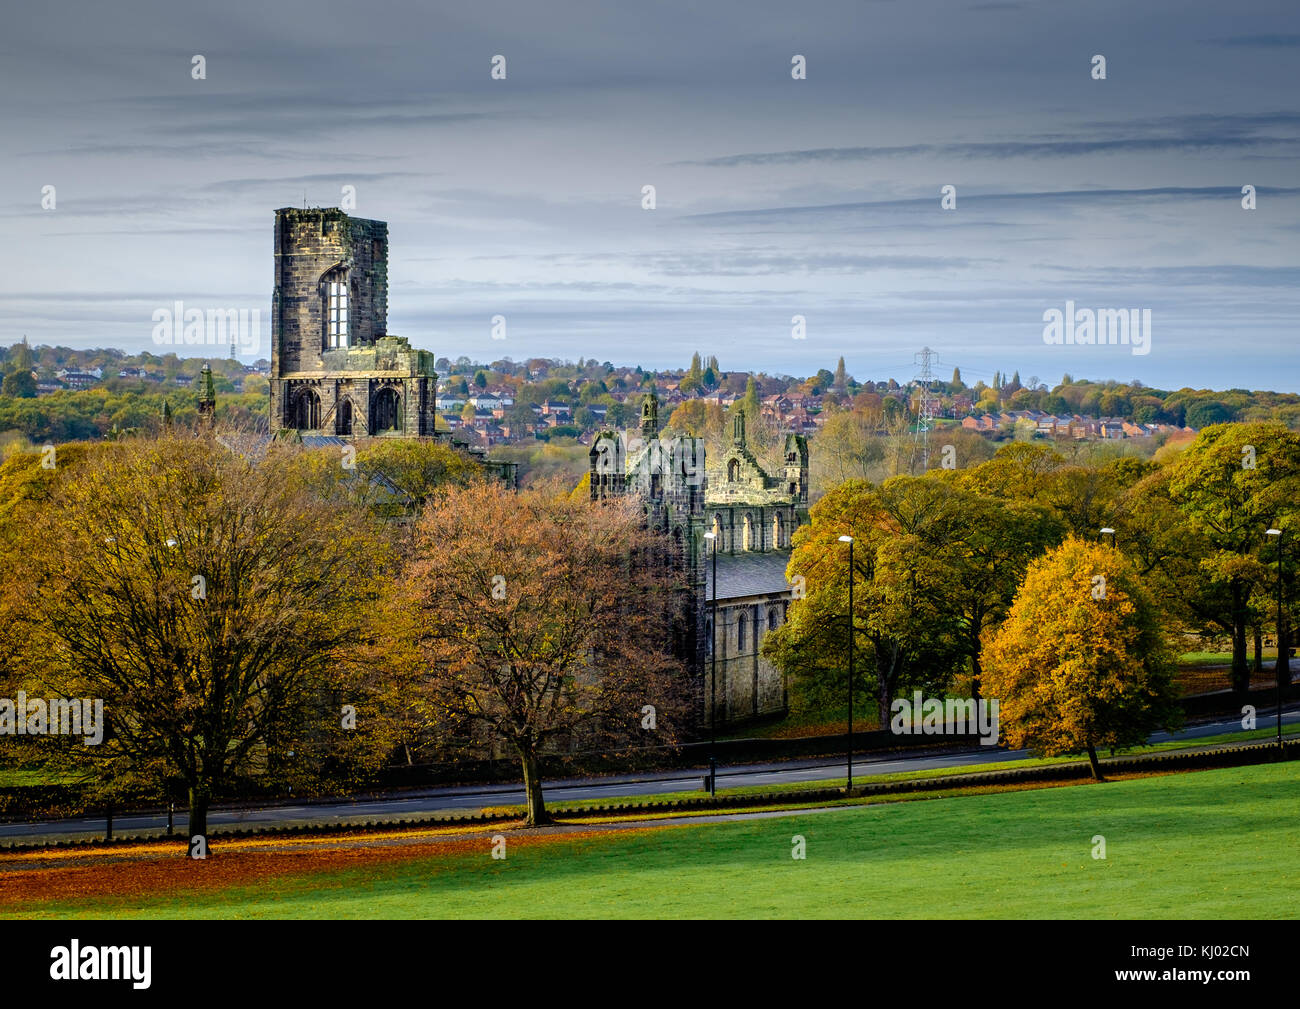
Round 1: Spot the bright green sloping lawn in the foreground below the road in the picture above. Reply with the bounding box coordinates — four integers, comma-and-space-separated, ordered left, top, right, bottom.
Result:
23, 762, 1300, 918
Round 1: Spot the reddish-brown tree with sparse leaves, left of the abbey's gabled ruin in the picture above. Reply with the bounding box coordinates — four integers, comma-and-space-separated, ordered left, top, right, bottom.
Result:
406, 482, 685, 826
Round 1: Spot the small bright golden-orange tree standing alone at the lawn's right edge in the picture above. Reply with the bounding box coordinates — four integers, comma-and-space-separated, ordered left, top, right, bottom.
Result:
984, 537, 1180, 780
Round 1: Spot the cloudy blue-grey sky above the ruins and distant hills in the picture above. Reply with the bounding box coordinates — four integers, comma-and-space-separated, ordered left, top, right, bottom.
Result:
0, 0, 1300, 391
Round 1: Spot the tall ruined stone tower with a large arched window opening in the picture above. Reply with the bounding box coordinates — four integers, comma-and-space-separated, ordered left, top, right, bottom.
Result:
270, 207, 438, 437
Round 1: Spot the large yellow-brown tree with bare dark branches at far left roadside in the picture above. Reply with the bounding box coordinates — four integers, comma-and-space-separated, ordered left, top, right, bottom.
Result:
12, 436, 386, 852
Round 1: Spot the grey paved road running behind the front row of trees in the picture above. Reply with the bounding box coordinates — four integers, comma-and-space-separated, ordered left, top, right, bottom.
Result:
0, 707, 1300, 841
